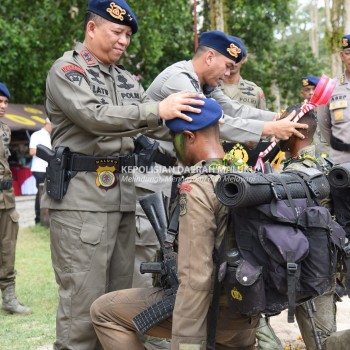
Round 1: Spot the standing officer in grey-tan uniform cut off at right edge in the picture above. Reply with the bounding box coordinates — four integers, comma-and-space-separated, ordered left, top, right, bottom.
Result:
317, 34, 350, 163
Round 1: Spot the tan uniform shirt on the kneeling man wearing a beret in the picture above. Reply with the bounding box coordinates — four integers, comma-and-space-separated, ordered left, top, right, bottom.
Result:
172, 161, 228, 349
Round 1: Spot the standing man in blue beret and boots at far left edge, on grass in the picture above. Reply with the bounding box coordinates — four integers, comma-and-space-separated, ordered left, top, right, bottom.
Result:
0, 83, 32, 314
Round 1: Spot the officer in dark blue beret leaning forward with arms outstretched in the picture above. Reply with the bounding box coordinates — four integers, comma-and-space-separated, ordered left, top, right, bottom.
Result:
147, 30, 307, 144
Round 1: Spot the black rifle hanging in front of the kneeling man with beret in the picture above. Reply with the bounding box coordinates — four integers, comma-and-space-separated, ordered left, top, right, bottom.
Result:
133, 192, 180, 334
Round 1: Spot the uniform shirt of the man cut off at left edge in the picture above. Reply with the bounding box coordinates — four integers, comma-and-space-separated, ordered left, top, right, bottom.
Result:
0, 121, 15, 209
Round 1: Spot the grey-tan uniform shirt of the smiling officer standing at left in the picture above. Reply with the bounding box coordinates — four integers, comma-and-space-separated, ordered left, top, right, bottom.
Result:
42, 43, 165, 212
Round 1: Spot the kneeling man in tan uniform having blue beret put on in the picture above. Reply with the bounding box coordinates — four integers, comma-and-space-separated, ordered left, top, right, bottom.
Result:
91, 99, 259, 350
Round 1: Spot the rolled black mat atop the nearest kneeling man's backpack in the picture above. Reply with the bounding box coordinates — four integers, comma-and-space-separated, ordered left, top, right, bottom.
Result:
215, 168, 330, 208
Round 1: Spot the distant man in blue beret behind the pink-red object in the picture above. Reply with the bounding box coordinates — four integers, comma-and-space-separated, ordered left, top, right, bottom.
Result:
300, 75, 330, 158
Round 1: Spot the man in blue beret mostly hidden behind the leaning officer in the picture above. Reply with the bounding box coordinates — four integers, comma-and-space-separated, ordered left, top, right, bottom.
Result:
220, 36, 267, 110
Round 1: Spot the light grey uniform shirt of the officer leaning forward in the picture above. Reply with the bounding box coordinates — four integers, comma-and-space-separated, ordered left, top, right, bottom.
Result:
147, 61, 275, 143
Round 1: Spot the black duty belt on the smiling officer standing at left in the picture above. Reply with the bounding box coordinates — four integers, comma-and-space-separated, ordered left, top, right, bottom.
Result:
66, 153, 136, 173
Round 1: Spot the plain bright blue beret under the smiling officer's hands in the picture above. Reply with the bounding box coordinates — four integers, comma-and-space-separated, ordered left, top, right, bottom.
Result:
165, 98, 223, 132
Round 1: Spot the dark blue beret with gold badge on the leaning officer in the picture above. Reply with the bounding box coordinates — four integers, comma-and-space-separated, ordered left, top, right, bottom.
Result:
199, 30, 243, 63
